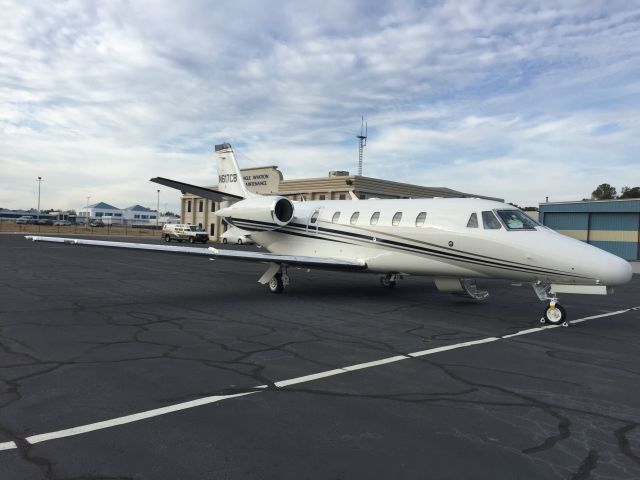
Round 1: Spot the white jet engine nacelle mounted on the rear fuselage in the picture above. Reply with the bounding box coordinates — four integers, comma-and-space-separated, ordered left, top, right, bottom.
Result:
216, 196, 294, 230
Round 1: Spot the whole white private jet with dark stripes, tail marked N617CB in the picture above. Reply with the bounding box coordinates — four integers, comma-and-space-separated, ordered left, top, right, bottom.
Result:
26, 143, 631, 325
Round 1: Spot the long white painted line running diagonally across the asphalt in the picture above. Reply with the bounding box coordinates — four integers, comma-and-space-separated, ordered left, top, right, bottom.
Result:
0, 307, 640, 451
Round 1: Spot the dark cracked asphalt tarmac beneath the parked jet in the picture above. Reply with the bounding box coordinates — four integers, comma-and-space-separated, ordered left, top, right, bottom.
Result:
0, 234, 640, 480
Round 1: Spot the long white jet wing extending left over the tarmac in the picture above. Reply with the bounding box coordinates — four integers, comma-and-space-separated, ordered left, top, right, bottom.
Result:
25, 235, 367, 270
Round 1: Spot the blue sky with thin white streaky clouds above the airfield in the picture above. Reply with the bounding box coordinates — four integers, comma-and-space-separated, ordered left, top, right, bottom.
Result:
0, 0, 640, 209
